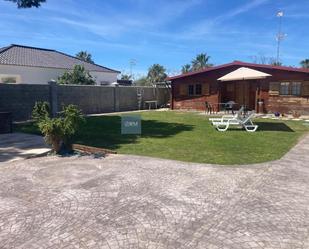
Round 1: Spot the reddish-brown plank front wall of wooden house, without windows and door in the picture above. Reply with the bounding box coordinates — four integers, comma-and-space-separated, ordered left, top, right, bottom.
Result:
172, 65, 309, 114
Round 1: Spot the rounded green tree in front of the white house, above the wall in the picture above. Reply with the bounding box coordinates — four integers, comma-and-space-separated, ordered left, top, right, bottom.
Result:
58, 65, 95, 85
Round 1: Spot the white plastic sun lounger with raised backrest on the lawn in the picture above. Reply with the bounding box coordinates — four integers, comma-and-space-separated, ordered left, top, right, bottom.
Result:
214, 113, 258, 132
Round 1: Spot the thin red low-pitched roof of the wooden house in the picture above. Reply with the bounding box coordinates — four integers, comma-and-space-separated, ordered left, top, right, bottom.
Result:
167, 61, 309, 80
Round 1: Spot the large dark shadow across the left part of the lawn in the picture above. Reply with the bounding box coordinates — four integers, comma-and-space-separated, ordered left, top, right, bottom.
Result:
76, 116, 193, 150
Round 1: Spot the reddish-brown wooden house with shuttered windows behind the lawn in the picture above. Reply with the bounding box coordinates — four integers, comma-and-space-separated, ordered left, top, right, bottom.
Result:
168, 61, 309, 114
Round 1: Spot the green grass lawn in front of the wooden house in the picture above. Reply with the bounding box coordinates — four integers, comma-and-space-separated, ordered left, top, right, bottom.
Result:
16, 111, 309, 164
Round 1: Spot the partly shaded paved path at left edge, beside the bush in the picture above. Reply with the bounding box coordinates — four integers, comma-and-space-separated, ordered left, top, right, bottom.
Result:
0, 133, 50, 162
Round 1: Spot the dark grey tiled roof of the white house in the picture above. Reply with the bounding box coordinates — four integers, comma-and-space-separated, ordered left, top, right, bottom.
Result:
0, 44, 119, 73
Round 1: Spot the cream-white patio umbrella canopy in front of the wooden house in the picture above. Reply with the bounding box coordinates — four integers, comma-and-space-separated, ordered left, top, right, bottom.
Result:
218, 67, 271, 81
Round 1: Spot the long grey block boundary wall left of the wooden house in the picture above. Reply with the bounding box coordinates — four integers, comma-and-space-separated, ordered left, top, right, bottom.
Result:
0, 84, 169, 121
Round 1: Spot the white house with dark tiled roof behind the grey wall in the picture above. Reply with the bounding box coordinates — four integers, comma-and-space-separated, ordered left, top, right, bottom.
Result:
0, 44, 120, 85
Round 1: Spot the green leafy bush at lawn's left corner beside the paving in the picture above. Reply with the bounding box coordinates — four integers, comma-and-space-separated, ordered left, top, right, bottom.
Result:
32, 102, 84, 153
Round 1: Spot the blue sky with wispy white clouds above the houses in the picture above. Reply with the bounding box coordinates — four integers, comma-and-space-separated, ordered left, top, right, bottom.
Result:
0, 0, 309, 75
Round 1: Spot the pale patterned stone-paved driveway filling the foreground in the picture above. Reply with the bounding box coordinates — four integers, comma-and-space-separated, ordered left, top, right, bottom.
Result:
0, 137, 309, 249
